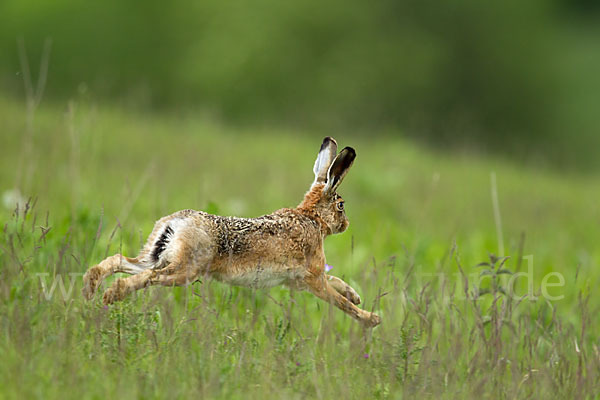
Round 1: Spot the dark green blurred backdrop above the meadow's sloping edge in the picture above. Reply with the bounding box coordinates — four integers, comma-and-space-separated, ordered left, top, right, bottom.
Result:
0, 0, 600, 170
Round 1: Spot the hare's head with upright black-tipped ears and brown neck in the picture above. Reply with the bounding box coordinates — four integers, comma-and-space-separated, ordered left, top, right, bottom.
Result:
298, 137, 356, 235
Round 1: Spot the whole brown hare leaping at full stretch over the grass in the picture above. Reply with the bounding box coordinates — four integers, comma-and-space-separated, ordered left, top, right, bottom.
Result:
82, 137, 381, 327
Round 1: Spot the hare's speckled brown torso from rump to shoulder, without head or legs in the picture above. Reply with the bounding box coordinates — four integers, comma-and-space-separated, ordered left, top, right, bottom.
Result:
145, 209, 320, 274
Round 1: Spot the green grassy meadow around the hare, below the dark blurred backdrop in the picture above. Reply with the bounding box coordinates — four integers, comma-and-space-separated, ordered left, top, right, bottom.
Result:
0, 99, 600, 399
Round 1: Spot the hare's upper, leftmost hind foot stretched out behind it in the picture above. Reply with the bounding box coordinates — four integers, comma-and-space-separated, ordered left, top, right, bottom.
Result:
81, 254, 148, 300
